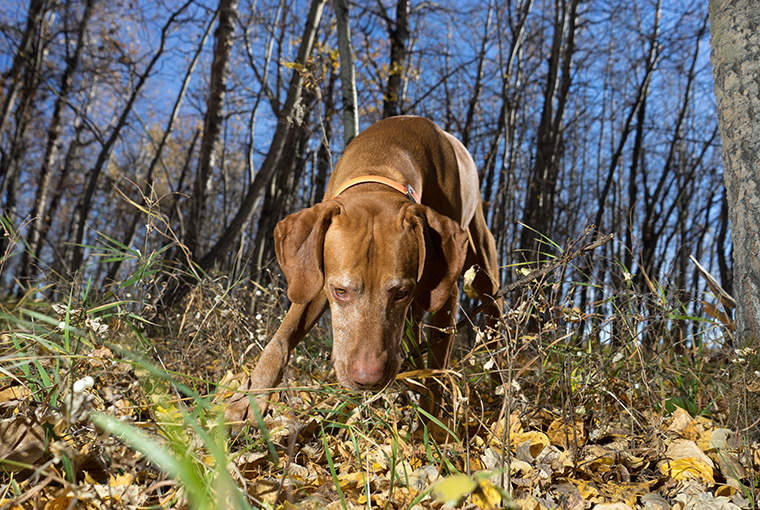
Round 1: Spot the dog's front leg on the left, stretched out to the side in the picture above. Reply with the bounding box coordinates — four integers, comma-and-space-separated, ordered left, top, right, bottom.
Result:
224, 292, 327, 427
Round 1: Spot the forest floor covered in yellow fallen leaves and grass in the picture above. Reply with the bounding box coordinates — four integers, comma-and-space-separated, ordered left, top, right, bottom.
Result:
0, 262, 760, 510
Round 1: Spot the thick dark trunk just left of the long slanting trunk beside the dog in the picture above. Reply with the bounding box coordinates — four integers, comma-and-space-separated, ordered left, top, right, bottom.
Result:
185, 0, 238, 259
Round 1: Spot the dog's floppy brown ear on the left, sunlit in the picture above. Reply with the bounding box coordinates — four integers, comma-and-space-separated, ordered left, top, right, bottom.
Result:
274, 201, 340, 304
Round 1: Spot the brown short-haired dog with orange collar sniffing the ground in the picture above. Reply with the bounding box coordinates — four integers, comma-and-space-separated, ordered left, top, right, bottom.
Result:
225, 117, 501, 423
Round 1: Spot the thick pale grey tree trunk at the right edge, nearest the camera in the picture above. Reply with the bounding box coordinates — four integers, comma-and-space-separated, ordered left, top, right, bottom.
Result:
710, 0, 760, 437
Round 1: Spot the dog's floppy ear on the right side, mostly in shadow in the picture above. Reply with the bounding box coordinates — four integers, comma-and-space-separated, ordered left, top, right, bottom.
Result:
406, 205, 467, 312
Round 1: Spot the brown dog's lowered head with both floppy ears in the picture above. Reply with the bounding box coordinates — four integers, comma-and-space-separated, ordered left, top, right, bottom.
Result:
275, 197, 467, 390
